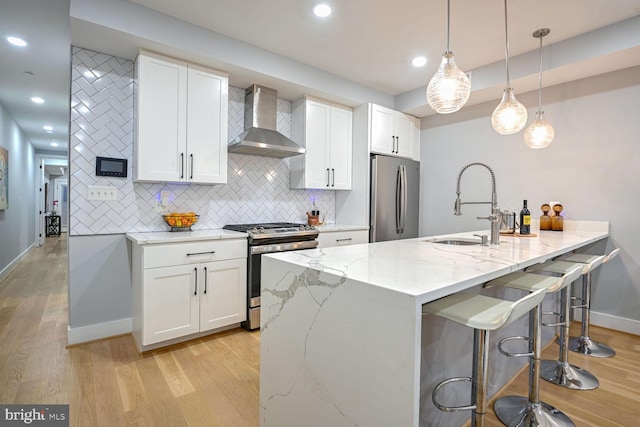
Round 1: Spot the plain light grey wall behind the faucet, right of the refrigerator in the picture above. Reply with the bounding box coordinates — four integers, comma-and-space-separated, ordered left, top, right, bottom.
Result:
421, 67, 640, 334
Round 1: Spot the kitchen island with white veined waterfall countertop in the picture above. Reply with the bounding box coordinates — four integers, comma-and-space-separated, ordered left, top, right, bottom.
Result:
260, 221, 609, 427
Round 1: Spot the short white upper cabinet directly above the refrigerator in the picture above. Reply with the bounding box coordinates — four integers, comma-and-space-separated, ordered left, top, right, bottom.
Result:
369, 104, 420, 160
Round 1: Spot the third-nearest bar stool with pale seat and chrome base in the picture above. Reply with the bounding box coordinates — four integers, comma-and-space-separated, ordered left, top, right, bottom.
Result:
525, 256, 604, 390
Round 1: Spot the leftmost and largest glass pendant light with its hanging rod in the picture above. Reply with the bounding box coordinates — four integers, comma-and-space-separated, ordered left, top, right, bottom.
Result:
427, 0, 471, 114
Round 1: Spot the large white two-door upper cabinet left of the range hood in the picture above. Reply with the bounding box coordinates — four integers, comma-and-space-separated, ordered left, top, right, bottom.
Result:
134, 52, 229, 184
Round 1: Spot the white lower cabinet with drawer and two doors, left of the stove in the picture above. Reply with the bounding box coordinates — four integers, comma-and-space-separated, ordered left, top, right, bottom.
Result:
132, 240, 247, 350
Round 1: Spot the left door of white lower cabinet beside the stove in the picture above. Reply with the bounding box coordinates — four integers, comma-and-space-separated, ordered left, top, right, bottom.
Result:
142, 265, 198, 345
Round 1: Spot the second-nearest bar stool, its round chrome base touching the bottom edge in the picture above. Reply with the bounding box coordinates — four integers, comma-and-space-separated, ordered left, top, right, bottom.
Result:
485, 265, 582, 427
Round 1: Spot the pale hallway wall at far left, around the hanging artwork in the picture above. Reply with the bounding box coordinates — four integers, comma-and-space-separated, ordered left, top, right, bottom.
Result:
0, 100, 36, 281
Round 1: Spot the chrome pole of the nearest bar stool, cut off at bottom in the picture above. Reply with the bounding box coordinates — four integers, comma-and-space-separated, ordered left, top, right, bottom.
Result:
471, 329, 489, 427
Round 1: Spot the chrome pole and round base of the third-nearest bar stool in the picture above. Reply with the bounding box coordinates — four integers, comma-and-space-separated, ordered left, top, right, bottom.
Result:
540, 286, 600, 390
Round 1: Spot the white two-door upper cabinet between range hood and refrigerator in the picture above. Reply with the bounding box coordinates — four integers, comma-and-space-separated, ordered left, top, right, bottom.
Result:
290, 98, 353, 190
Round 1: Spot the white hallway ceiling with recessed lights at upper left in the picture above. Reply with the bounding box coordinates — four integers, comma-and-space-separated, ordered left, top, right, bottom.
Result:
0, 0, 71, 151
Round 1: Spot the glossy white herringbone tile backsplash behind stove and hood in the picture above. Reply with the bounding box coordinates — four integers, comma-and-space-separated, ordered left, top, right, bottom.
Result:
69, 47, 335, 235
